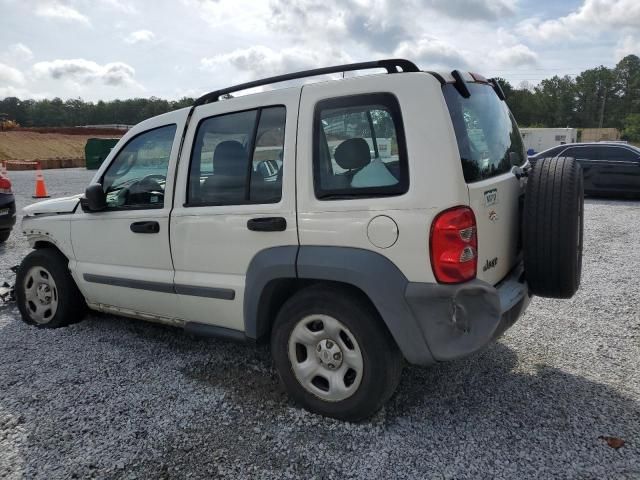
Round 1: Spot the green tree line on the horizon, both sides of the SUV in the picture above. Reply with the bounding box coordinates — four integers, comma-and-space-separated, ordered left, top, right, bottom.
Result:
0, 55, 640, 142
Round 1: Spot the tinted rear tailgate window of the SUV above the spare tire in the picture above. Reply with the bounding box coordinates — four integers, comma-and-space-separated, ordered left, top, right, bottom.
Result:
443, 83, 526, 183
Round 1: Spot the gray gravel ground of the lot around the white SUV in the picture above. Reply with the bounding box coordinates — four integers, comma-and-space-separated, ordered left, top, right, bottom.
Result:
0, 170, 640, 479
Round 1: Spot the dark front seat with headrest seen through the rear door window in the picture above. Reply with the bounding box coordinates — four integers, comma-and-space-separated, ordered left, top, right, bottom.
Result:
202, 140, 249, 204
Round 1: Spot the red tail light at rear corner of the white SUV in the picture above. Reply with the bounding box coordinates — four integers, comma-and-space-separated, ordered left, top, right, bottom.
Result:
429, 207, 478, 283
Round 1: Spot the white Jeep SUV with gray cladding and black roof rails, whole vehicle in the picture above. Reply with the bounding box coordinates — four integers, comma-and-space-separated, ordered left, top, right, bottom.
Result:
16, 60, 583, 420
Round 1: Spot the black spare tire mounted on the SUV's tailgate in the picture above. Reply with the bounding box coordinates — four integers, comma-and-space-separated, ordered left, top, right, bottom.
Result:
522, 157, 584, 298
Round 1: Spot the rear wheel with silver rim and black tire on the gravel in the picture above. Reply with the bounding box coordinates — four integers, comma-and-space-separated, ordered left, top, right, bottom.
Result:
271, 286, 403, 422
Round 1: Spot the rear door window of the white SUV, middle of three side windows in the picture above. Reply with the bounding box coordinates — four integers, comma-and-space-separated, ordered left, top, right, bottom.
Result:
187, 107, 286, 206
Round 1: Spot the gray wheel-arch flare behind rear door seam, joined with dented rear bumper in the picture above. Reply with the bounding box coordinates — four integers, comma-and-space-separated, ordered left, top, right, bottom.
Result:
297, 246, 530, 365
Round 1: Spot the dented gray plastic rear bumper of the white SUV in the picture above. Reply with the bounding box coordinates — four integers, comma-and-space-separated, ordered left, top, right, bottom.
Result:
403, 264, 531, 364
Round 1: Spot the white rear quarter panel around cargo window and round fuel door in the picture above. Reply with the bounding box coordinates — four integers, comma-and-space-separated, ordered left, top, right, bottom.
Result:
296, 73, 469, 282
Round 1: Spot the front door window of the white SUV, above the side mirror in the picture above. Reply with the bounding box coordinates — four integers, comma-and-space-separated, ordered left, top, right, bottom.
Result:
102, 125, 177, 209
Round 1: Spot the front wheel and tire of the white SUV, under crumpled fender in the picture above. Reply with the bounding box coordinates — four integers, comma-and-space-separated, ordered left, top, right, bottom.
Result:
16, 248, 87, 328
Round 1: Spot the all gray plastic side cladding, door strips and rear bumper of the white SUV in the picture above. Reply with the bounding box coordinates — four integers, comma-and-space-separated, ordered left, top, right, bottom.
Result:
100, 246, 529, 365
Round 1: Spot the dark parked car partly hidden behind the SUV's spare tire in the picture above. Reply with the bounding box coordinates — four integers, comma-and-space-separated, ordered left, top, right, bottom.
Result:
529, 142, 640, 195
